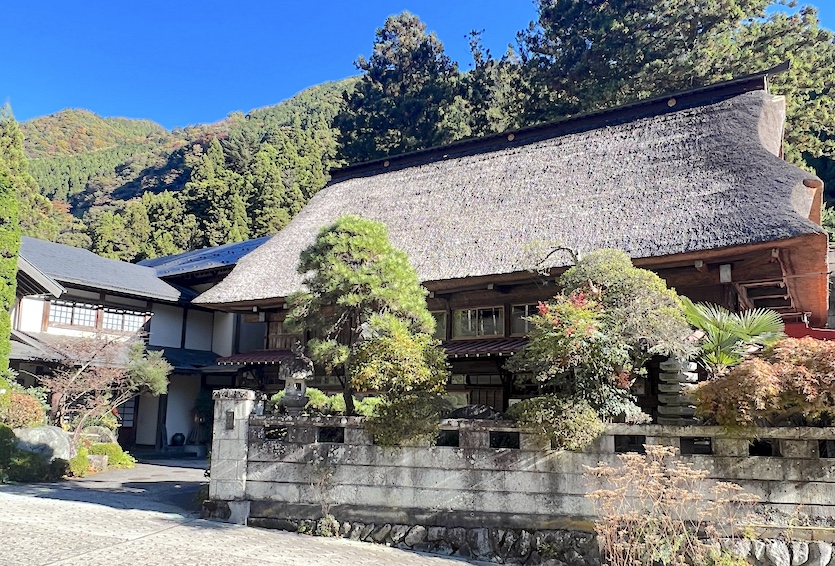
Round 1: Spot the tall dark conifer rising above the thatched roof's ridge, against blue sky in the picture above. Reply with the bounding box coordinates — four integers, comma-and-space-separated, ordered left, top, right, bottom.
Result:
334, 12, 458, 163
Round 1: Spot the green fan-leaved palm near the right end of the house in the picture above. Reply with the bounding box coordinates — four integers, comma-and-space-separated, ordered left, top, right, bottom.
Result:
681, 297, 786, 377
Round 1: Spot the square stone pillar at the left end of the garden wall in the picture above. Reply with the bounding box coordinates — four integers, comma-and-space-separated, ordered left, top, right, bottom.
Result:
209, 389, 256, 524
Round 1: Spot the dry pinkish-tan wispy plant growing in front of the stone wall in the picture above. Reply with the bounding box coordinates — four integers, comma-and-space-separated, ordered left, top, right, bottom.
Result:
586, 446, 756, 566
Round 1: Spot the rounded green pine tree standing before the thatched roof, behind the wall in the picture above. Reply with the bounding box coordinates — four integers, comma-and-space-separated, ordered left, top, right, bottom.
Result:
287, 216, 446, 414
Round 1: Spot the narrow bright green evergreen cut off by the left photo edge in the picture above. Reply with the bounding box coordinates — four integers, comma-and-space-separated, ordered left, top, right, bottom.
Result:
0, 105, 23, 377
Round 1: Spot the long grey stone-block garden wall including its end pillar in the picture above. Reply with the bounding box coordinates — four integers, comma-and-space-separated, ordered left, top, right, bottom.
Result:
210, 390, 835, 565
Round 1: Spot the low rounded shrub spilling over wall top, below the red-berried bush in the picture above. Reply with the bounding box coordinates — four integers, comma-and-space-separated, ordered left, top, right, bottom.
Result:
507, 395, 604, 450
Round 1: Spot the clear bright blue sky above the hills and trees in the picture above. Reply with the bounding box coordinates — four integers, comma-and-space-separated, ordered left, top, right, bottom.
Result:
8, 0, 835, 128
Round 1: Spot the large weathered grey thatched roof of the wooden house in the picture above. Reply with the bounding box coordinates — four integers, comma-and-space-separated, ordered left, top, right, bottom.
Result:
195, 87, 822, 305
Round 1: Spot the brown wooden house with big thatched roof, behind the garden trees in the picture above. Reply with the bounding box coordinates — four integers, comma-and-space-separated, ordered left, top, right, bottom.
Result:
194, 73, 828, 408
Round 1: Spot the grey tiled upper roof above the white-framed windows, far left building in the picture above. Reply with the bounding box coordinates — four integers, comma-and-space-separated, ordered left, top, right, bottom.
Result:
20, 236, 181, 302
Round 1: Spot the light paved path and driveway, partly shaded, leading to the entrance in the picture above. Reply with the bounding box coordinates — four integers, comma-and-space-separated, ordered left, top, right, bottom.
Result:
0, 461, 480, 566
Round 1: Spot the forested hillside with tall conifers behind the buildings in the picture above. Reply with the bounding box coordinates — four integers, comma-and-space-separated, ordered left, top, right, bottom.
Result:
16, 0, 835, 261
